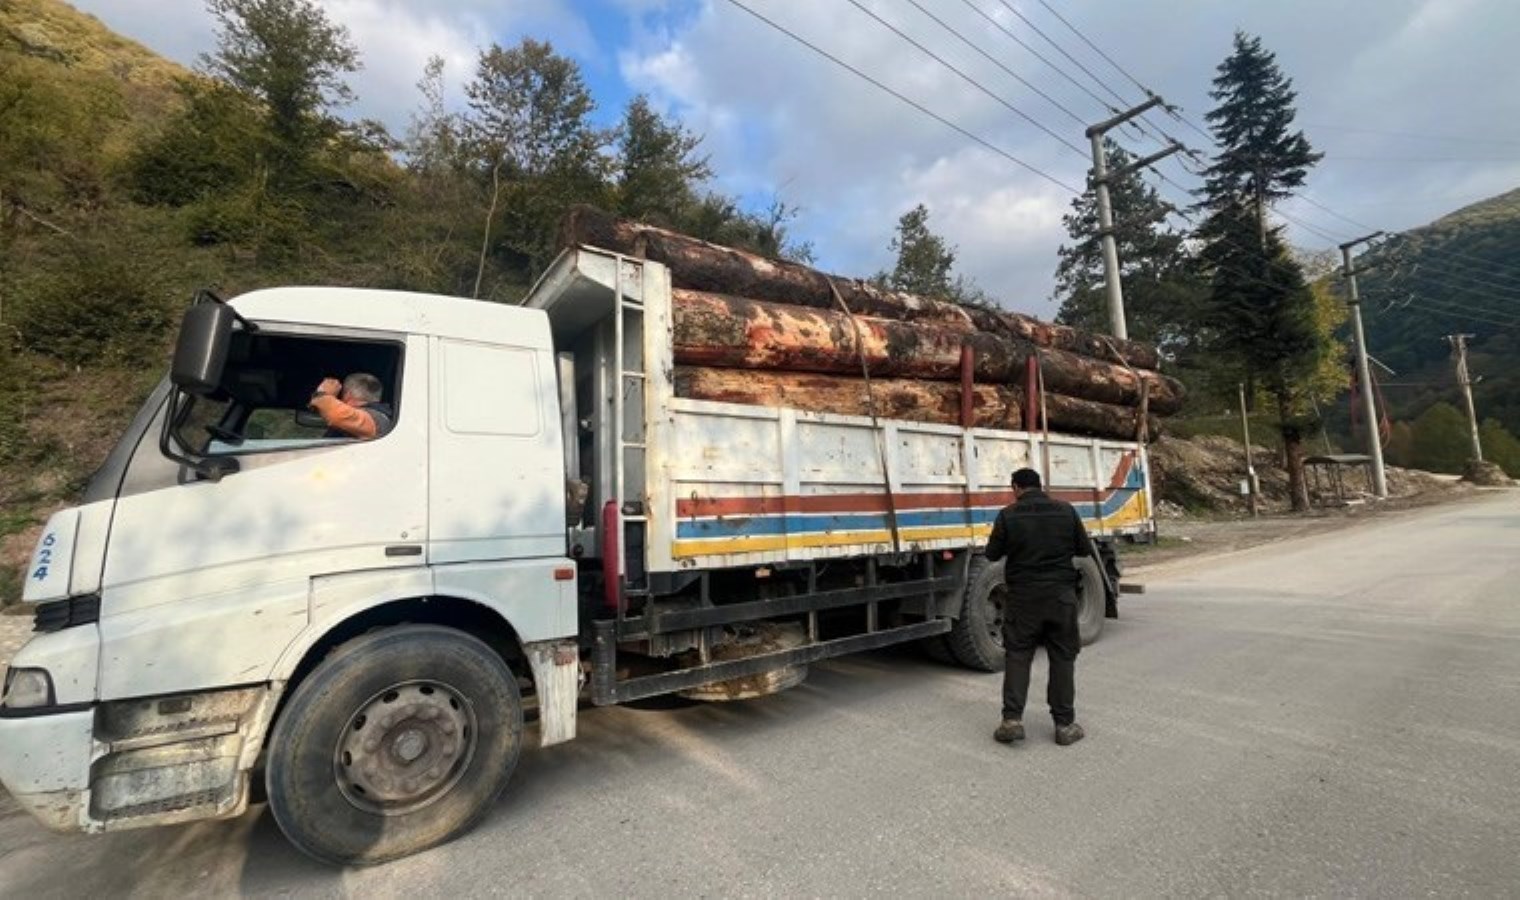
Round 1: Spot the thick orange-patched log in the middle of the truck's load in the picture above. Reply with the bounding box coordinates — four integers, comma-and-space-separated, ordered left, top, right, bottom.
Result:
673, 287, 1183, 415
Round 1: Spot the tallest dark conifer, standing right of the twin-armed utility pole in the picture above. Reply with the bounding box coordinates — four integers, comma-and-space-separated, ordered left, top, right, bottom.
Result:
1199, 32, 1335, 509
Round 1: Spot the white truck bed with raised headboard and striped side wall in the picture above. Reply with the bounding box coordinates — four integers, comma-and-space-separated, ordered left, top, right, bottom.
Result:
529, 248, 1154, 573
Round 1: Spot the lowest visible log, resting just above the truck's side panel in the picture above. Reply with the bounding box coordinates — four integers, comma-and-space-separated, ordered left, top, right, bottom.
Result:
675, 366, 1160, 441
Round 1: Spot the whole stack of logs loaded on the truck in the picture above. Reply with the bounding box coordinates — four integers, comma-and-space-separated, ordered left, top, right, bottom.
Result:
561, 207, 1183, 439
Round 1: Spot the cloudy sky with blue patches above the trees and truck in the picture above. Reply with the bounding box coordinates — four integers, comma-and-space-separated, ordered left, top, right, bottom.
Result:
73, 0, 1520, 315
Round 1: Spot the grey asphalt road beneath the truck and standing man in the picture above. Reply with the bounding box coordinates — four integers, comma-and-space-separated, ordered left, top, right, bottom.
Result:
0, 493, 1520, 898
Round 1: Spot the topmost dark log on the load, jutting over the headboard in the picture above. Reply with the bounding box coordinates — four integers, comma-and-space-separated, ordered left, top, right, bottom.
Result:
559, 207, 1161, 369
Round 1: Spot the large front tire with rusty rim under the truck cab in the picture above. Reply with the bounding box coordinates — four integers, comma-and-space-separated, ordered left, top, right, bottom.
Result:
266, 625, 523, 865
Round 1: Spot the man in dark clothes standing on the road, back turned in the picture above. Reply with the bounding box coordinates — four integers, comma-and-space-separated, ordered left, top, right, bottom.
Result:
986, 468, 1093, 746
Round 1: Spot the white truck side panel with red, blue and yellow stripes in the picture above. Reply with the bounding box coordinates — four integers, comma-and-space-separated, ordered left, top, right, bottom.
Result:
649, 398, 1151, 572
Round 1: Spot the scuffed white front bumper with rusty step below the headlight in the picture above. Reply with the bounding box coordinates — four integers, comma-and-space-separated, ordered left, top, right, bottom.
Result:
0, 686, 278, 832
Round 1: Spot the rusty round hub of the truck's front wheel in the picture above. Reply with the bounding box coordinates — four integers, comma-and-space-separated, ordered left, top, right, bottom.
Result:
333, 681, 476, 815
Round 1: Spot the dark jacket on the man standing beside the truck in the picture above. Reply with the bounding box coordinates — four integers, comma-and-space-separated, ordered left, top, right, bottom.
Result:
986, 490, 1093, 585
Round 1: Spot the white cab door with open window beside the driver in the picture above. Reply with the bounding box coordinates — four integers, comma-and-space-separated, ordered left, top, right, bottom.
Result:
100, 325, 429, 699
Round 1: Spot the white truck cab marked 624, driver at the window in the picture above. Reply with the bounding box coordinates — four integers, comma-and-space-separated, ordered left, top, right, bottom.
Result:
0, 287, 579, 857
